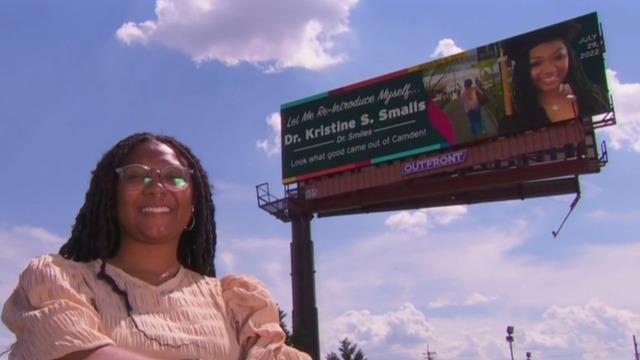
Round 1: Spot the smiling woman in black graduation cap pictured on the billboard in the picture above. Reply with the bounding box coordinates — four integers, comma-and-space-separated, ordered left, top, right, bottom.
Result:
502, 22, 608, 129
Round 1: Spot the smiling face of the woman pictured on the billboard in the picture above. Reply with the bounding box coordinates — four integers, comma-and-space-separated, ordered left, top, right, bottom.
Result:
529, 40, 569, 92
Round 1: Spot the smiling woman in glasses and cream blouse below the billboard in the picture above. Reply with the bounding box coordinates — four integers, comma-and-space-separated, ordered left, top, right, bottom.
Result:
2, 133, 309, 360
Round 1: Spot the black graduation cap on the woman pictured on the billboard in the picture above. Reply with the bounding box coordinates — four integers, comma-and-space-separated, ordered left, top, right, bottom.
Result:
501, 21, 582, 60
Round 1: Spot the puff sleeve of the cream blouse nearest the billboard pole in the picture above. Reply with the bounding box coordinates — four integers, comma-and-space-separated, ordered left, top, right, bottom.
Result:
221, 275, 311, 360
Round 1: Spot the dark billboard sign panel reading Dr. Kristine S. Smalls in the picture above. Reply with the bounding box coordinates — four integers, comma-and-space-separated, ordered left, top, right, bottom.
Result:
281, 13, 610, 184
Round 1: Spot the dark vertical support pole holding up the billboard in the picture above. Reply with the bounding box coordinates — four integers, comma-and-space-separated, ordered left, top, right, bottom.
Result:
289, 206, 320, 360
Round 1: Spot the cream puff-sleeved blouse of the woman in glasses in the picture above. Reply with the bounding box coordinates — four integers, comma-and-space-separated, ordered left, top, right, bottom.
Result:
2, 255, 310, 360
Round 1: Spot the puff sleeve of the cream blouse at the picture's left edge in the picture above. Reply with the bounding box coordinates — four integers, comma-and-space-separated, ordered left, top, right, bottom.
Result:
2, 255, 113, 360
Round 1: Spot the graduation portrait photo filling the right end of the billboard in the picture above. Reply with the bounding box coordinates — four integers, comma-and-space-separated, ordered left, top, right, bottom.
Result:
499, 13, 611, 133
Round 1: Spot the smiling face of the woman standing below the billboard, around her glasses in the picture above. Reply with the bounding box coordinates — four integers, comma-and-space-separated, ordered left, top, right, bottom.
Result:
117, 140, 193, 248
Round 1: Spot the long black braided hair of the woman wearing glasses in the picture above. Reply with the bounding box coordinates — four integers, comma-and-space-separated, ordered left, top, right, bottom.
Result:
59, 133, 216, 276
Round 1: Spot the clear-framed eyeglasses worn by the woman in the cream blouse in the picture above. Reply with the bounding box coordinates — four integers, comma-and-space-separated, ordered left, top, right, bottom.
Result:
116, 164, 193, 191
